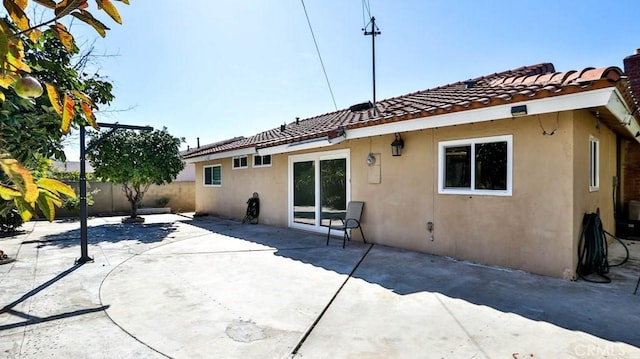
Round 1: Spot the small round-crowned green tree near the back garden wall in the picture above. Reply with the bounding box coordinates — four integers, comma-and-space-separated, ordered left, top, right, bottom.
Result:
87, 128, 184, 219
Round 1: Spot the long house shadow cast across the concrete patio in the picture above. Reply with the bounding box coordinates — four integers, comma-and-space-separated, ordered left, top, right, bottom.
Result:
186, 217, 640, 346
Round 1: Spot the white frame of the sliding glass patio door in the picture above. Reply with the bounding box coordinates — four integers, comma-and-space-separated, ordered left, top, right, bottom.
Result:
287, 148, 351, 235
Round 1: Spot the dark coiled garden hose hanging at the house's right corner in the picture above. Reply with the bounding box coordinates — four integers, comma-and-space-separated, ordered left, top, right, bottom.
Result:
576, 210, 629, 283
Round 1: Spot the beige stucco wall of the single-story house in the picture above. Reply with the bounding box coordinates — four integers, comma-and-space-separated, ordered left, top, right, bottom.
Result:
196, 112, 615, 278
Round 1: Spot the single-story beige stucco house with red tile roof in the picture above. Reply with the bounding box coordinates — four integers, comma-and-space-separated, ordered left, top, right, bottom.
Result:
184, 52, 640, 279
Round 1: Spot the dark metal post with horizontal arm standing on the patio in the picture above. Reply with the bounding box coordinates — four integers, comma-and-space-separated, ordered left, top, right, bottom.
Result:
76, 123, 153, 264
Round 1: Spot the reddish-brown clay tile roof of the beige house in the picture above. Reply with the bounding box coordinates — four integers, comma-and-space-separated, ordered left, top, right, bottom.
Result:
183, 63, 628, 159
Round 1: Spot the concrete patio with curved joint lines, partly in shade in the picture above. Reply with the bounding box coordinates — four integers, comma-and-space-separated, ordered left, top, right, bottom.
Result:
0, 214, 640, 358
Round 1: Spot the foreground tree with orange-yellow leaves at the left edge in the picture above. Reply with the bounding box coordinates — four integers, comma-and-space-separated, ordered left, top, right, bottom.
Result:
0, 0, 129, 220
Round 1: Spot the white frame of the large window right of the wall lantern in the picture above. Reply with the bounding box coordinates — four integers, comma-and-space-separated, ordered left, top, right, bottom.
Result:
438, 135, 513, 196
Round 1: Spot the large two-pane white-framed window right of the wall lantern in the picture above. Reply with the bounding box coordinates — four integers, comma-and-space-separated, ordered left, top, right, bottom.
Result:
438, 135, 513, 196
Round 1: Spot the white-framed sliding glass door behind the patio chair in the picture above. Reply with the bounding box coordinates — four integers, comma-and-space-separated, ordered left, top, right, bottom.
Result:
289, 150, 350, 231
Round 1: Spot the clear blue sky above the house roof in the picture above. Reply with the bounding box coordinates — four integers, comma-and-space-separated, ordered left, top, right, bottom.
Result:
62, 0, 640, 160
